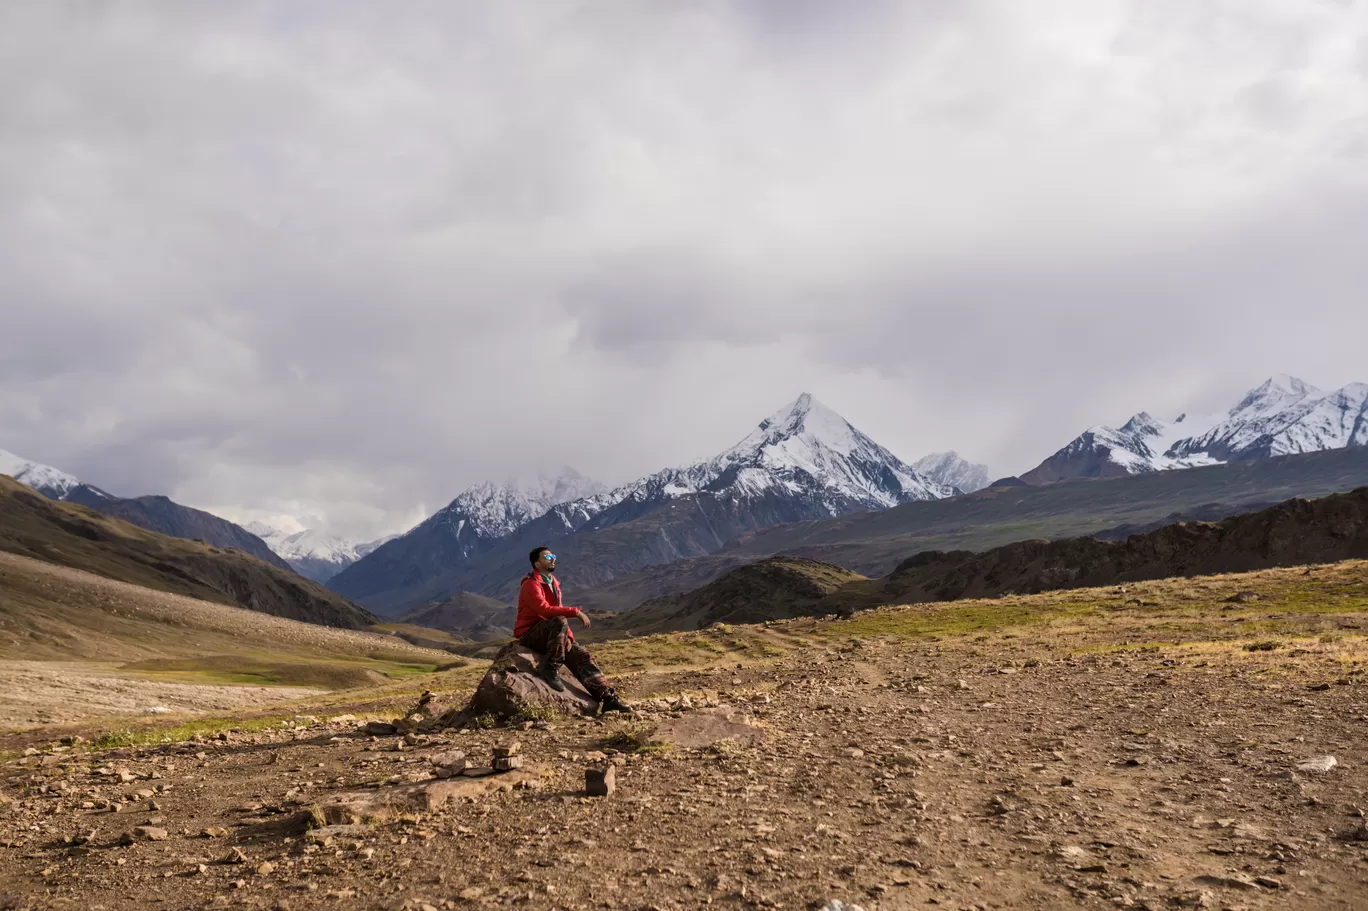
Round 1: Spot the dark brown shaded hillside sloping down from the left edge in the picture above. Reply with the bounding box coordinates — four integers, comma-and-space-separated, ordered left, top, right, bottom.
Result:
0, 476, 375, 629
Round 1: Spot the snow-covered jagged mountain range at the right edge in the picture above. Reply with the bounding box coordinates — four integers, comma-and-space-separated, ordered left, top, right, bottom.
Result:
1022, 375, 1368, 484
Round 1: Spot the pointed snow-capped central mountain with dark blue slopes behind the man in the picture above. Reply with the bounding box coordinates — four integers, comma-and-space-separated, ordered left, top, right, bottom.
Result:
331, 394, 955, 613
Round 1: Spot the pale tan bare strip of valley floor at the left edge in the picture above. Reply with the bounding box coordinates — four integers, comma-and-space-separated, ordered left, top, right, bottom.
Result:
0, 661, 319, 729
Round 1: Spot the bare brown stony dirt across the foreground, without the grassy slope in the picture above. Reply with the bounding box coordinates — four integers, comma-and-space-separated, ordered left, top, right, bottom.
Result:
0, 631, 1368, 910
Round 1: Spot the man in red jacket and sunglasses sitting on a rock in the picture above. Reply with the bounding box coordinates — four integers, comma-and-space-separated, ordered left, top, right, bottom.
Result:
513, 547, 631, 711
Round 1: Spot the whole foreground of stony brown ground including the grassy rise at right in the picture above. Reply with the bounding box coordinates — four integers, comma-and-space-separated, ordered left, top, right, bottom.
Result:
0, 562, 1368, 911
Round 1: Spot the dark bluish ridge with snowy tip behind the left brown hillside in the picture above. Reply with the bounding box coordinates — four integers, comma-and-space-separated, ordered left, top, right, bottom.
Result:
0, 440, 290, 569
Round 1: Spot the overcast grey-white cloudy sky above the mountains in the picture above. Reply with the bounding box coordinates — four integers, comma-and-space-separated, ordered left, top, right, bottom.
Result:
0, 0, 1368, 535
